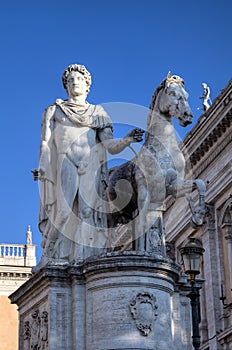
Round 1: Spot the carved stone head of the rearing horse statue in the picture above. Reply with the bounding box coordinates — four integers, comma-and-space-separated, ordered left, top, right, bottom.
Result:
153, 72, 193, 126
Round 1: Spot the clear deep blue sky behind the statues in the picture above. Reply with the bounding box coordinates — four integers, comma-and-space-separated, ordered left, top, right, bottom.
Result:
0, 0, 232, 257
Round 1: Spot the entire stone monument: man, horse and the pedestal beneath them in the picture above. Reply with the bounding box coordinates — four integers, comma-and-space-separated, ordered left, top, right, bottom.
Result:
24, 64, 205, 350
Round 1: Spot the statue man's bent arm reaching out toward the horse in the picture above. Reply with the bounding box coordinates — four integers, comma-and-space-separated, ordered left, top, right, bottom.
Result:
98, 127, 144, 154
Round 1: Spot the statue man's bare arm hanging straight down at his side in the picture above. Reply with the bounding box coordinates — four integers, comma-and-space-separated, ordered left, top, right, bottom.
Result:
38, 105, 56, 177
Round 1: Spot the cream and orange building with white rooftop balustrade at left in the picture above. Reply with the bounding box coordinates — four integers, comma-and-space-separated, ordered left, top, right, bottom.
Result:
0, 226, 36, 350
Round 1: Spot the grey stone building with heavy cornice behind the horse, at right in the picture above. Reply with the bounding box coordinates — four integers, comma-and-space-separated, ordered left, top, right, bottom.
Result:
165, 80, 232, 350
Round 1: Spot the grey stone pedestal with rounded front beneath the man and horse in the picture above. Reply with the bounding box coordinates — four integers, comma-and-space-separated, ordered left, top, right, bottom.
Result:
10, 251, 191, 350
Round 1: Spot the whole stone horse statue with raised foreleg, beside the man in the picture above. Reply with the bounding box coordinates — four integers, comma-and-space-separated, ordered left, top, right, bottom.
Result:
107, 72, 205, 255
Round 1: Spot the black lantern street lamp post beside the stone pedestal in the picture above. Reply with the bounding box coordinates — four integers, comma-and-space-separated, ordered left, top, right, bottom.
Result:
180, 237, 205, 349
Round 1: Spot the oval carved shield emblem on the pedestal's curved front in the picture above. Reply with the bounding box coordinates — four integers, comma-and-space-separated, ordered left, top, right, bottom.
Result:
130, 292, 158, 336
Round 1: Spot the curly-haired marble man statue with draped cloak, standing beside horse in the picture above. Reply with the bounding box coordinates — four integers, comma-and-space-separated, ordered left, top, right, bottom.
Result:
37, 64, 143, 265
